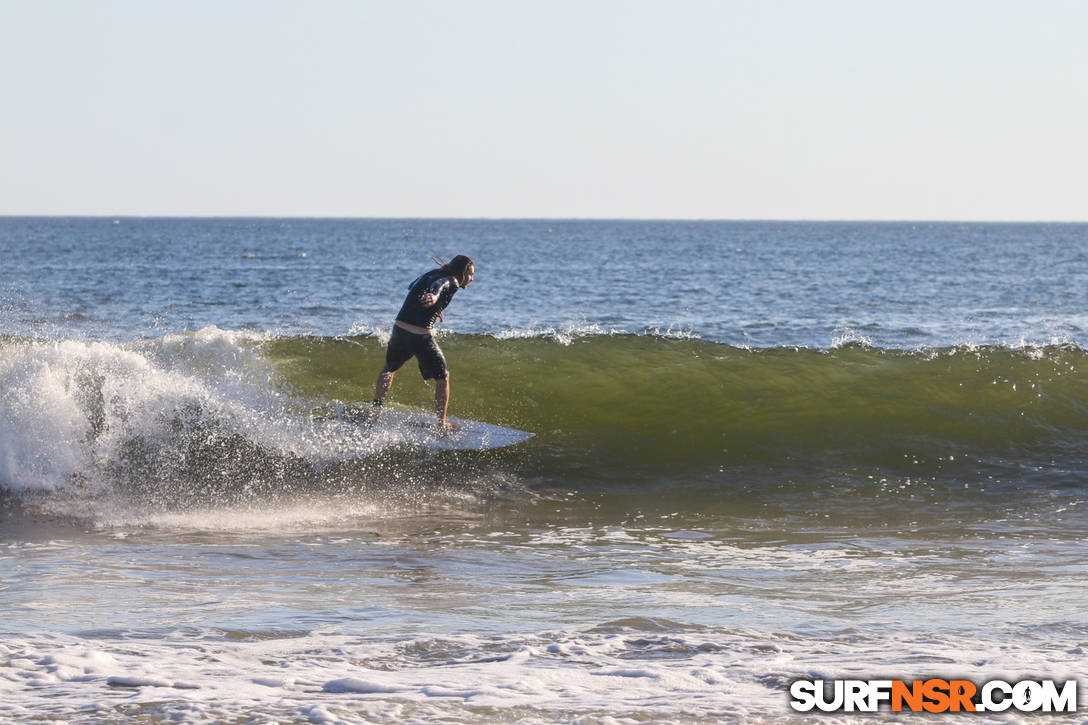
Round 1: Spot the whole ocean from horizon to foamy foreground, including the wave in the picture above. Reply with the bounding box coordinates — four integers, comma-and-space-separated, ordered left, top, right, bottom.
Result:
0, 218, 1088, 725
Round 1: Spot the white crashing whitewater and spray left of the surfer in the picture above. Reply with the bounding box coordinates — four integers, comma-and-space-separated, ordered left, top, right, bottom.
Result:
0, 329, 522, 526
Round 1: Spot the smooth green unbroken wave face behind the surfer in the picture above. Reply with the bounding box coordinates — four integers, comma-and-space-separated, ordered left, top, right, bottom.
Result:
262, 335, 1088, 477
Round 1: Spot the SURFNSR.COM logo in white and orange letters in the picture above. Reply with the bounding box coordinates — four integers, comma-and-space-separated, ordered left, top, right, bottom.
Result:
790, 678, 1077, 712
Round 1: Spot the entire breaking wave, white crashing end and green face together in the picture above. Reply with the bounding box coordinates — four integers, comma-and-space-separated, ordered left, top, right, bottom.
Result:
0, 328, 1088, 507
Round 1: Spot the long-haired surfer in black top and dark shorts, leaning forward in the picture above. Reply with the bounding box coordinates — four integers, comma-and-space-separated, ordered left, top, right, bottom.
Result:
373, 255, 475, 430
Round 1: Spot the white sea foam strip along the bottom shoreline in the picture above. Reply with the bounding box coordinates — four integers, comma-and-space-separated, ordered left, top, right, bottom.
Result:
0, 623, 1085, 723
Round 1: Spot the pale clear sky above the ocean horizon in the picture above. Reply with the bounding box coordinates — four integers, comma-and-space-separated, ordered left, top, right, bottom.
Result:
0, 0, 1088, 221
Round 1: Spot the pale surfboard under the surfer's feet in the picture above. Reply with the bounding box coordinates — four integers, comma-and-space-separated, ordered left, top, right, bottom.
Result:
331, 405, 533, 451
